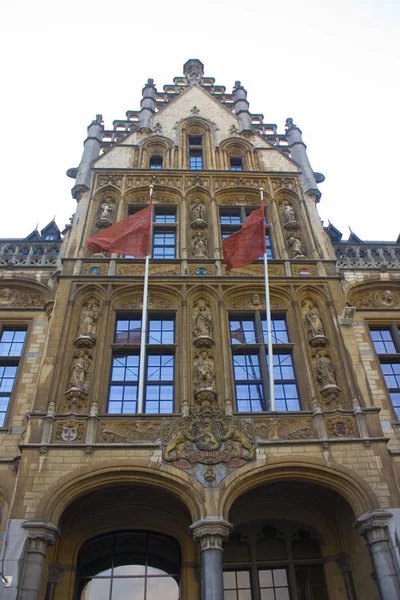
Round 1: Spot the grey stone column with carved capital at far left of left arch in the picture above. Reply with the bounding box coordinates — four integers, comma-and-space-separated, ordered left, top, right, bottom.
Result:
19, 520, 60, 600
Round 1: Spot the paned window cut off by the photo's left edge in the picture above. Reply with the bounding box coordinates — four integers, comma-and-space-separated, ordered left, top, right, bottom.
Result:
0, 329, 26, 427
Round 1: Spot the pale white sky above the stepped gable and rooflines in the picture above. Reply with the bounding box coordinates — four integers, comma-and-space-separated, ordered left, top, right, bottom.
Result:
0, 0, 400, 241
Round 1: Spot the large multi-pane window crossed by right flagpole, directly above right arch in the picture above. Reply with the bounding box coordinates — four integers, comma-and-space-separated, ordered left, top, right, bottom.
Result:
229, 312, 300, 412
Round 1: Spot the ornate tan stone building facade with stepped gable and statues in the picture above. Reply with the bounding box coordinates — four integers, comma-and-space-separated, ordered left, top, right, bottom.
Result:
0, 60, 400, 600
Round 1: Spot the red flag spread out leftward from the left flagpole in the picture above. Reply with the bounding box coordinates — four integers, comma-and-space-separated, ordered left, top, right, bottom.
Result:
86, 204, 151, 258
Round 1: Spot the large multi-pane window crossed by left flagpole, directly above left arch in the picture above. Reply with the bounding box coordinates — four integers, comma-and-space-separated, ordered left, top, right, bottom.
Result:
108, 316, 175, 414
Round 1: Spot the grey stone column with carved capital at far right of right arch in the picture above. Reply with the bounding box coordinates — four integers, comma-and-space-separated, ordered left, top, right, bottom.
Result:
355, 509, 400, 600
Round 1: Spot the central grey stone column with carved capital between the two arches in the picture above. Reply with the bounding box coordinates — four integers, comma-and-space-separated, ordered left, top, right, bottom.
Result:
190, 517, 232, 600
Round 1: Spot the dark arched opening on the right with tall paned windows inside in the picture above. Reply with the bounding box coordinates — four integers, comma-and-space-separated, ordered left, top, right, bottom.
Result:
223, 479, 376, 600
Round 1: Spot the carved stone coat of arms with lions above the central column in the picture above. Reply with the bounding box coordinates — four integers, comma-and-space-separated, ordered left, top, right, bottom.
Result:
162, 406, 255, 469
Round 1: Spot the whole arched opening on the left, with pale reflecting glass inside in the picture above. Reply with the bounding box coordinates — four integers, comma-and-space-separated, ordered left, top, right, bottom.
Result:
49, 481, 199, 600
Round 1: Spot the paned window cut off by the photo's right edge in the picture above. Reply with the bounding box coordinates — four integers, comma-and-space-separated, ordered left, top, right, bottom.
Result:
370, 323, 400, 420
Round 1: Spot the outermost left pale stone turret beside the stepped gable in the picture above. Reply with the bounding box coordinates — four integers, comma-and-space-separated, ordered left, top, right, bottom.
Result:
67, 115, 104, 200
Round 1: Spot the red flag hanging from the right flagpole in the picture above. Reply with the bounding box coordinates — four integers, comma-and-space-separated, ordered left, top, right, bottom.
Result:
222, 203, 266, 271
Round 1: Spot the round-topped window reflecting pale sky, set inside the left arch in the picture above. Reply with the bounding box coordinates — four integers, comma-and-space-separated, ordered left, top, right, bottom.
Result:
75, 531, 181, 600
